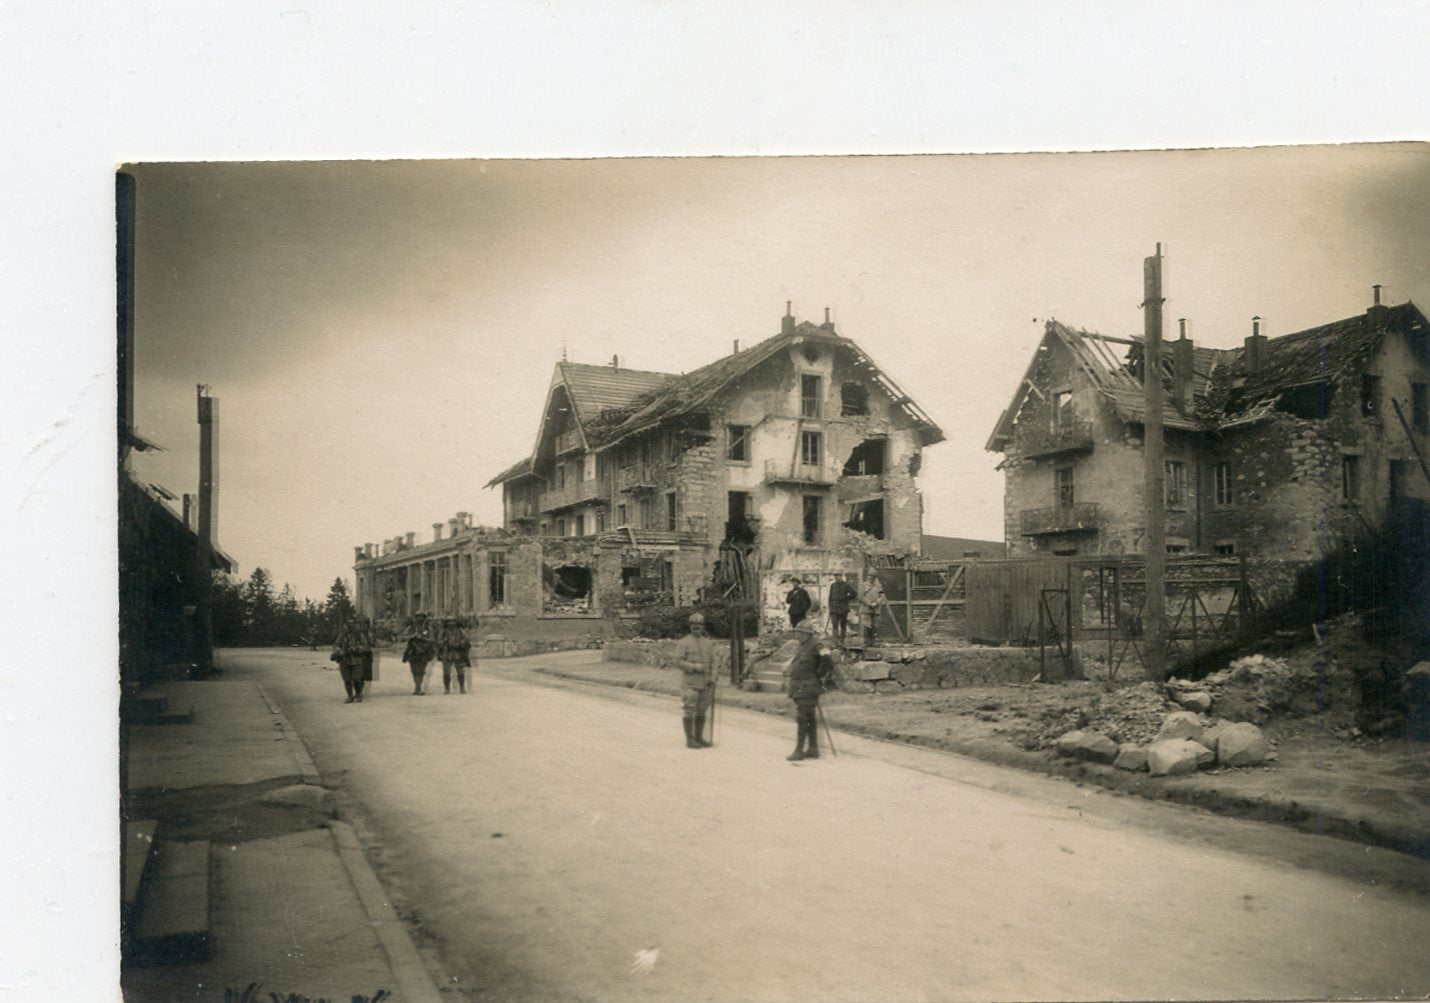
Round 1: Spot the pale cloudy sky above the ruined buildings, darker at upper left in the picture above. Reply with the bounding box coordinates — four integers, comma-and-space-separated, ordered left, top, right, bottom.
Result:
122, 145, 1430, 598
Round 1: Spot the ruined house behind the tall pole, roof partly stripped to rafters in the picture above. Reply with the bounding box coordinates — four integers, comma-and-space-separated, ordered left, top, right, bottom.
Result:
987, 286, 1430, 572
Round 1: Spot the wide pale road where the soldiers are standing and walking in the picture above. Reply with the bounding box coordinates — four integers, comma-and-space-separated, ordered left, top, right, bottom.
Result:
222, 651, 1430, 1000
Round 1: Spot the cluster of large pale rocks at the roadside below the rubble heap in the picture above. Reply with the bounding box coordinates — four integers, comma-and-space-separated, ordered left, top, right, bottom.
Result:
1054, 710, 1274, 777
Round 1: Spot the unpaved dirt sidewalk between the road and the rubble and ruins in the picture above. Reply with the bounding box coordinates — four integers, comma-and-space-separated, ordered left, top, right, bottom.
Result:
500, 651, 1430, 858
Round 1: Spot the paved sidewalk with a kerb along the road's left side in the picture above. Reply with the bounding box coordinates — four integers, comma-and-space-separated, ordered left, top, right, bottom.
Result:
122, 681, 440, 1003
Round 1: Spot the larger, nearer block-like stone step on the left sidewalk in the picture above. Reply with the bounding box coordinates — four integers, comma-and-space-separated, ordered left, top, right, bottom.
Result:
132, 840, 212, 964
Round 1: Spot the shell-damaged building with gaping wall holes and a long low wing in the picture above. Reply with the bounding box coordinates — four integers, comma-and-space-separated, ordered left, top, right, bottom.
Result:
355, 307, 944, 624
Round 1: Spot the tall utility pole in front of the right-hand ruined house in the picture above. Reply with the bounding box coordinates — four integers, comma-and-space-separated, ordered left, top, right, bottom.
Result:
1143, 243, 1167, 682
